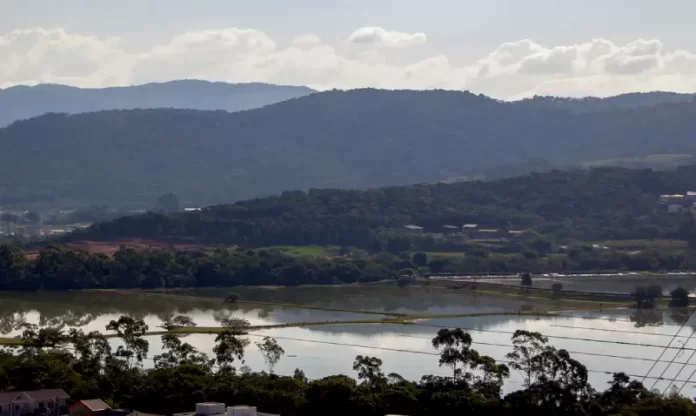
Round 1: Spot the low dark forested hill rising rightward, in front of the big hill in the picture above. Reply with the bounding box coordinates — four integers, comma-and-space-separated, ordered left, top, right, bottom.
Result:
70, 166, 696, 248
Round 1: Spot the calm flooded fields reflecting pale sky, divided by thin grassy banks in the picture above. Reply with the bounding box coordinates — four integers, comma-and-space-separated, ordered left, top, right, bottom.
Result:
0, 286, 696, 396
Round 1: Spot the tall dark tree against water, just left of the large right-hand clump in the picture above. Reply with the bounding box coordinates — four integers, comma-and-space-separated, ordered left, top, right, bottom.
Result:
432, 328, 480, 381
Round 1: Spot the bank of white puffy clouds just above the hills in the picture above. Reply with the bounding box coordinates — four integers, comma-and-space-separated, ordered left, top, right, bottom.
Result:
0, 27, 696, 99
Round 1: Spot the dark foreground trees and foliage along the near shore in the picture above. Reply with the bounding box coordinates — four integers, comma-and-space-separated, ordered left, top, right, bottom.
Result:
0, 316, 696, 416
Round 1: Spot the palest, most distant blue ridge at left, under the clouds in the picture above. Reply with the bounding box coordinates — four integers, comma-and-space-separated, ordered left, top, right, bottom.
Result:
0, 81, 315, 127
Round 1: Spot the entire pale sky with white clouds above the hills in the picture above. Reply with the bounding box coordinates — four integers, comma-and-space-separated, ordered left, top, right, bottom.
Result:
0, 0, 696, 99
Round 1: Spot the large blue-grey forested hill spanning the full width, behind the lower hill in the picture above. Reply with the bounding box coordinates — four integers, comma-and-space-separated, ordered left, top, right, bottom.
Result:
0, 90, 696, 207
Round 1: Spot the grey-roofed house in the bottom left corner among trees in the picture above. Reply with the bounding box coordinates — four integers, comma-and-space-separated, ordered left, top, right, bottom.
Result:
0, 389, 70, 416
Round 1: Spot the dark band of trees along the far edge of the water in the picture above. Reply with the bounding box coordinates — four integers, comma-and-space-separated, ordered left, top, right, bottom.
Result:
0, 245, 696, 291
